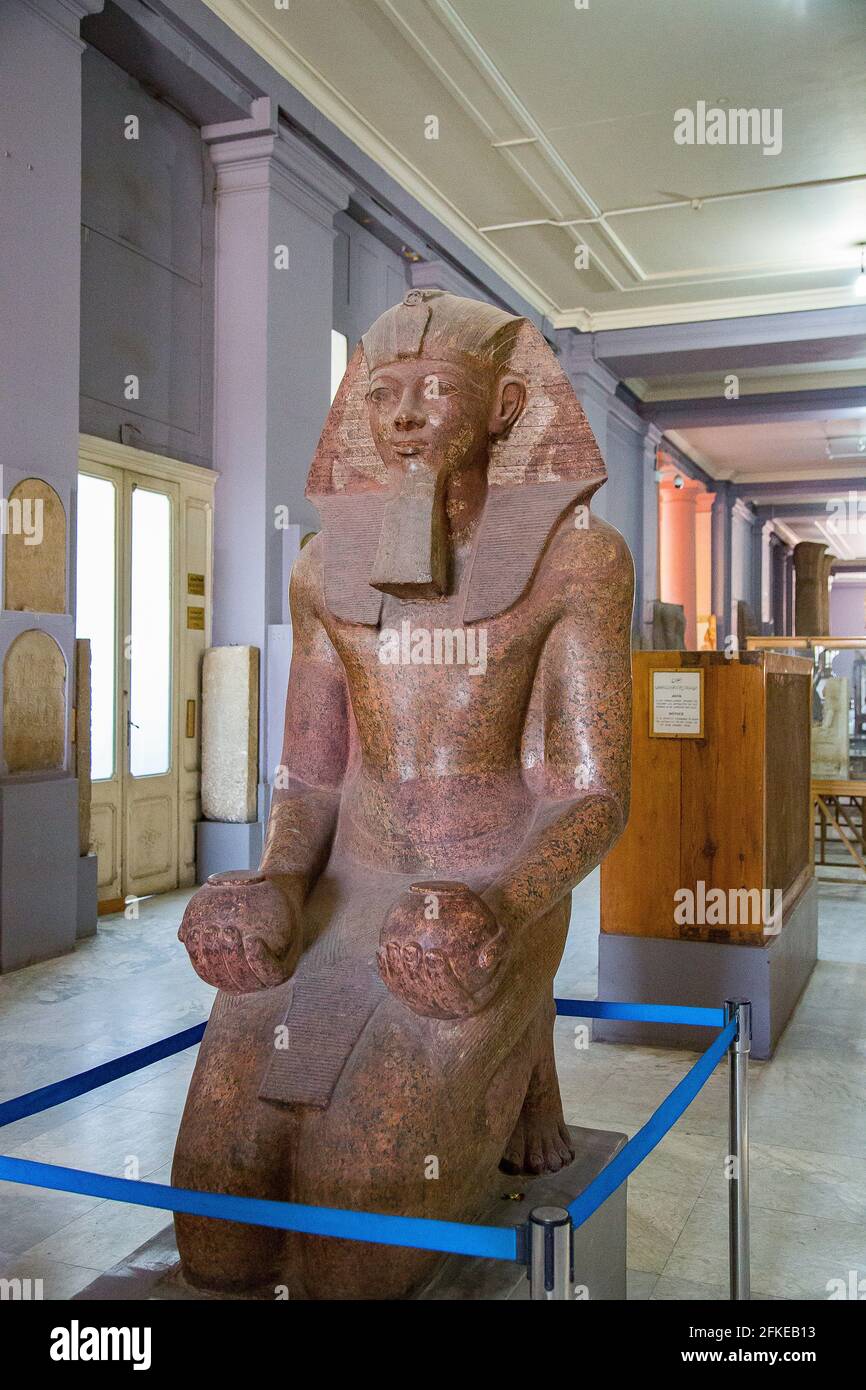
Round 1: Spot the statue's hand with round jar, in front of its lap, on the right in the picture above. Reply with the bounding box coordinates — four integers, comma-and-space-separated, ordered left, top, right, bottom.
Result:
378, 883, 506, 1019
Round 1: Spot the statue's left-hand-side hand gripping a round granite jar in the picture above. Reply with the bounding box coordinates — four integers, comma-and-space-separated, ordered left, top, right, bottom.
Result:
178, 870, 300, 994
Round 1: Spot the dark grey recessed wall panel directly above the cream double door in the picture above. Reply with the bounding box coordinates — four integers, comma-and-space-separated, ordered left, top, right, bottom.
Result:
81, 49, 214, 466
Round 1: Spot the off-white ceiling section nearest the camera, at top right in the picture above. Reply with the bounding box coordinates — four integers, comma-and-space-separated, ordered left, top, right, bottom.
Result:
207, 0, 866, 329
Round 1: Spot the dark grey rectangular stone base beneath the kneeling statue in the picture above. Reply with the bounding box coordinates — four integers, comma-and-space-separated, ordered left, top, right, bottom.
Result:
72, 1125, 627, 1302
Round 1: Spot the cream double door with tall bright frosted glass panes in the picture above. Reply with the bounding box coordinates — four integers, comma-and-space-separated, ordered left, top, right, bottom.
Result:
76, 442, 213, 912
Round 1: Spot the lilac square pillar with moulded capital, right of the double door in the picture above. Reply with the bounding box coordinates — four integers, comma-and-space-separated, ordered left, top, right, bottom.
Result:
199, 97, 352, 870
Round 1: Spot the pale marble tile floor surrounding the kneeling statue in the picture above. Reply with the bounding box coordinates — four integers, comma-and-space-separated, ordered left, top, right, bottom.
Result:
0, 874, 866, 1300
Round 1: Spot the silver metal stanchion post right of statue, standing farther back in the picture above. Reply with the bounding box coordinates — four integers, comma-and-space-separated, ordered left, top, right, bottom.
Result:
724, 999, 752, 1302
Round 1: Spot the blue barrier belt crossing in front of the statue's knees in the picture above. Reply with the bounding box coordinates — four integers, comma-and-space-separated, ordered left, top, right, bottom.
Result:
0, 1156, 518, 1261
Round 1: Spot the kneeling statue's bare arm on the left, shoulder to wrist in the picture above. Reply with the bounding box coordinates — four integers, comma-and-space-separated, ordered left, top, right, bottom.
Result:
259, 541, 349, 899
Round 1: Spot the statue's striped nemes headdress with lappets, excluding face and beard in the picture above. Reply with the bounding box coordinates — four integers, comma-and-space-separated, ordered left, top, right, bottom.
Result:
306, 289, 607, 626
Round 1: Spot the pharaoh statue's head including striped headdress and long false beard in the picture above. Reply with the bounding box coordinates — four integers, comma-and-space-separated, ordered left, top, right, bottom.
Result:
307, 289, 605, 623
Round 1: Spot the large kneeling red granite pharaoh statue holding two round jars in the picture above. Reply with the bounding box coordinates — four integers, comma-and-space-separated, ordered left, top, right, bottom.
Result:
172, 291, 632, 1298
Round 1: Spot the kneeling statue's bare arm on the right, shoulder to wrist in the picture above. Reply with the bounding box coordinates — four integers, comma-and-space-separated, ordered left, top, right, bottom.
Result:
484, 523, 634, 933
